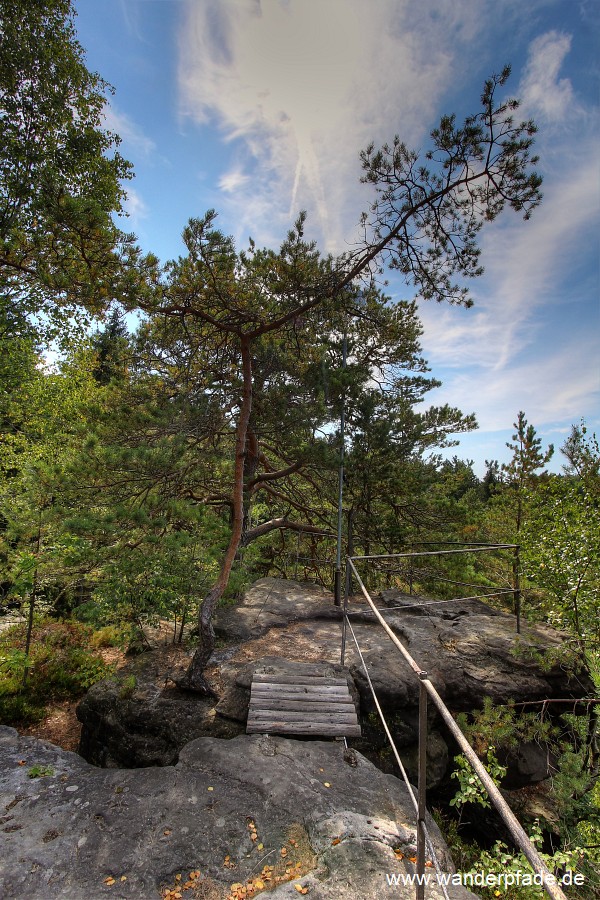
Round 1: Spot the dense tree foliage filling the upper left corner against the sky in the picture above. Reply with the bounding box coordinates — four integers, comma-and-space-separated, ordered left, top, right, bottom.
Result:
0, 0, 161, 343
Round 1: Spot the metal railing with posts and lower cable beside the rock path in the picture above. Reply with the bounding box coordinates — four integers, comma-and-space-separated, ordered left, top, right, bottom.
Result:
341, 544, 566, 900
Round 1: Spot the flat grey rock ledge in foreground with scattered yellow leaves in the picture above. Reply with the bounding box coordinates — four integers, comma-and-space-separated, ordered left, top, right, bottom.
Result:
0, 727, 474, 900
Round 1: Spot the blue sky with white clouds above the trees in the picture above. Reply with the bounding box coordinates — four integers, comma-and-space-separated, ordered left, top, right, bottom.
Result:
75, 0, 600, 475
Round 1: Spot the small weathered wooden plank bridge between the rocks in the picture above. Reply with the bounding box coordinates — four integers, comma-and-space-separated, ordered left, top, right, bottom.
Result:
246, 672, 360, 737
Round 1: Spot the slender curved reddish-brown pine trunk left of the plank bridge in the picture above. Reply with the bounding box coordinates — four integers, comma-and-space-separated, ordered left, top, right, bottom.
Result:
177, 338, 252, 695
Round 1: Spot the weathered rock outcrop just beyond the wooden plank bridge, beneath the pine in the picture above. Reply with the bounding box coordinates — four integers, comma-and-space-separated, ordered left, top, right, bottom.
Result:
78, 578, 593, 787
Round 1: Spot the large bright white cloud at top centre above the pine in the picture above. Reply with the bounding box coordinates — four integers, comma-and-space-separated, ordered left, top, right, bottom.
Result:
179, 0, 492, 250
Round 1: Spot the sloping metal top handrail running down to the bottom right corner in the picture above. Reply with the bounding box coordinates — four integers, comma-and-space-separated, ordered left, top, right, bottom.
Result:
346, 545, 566, 900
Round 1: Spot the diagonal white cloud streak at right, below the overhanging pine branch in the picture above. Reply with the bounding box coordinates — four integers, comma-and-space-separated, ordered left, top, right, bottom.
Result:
420, 137, 600, 370
